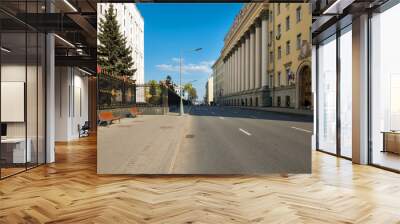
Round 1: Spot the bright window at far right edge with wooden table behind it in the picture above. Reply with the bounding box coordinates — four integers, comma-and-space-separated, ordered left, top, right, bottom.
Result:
370, 4, 400, 170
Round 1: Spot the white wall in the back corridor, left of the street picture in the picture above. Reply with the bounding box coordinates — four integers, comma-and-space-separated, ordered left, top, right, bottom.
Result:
55, 67, 89, 141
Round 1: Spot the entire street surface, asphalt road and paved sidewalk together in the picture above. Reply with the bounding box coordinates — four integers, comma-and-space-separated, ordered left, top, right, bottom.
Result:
98, 106, 312, 174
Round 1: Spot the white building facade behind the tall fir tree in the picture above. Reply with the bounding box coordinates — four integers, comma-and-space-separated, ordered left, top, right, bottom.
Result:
97, 3, 144, 102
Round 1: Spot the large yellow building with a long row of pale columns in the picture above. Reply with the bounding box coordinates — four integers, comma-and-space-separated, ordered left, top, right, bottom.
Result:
214, 3, 312, 109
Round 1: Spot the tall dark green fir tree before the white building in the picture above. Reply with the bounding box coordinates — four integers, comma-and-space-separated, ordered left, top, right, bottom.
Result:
97, 4, 135, 77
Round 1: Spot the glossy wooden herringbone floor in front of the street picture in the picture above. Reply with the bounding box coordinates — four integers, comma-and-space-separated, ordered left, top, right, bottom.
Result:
0, 138, 400, 224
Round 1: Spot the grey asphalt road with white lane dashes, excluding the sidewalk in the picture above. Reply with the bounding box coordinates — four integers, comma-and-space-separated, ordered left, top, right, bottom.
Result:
169, 106, 313, 174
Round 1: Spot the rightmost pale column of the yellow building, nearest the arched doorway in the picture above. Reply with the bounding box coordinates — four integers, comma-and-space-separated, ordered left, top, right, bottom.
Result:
261, 12, 269, 88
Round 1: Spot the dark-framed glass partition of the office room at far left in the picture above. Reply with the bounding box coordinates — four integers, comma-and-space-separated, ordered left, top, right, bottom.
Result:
0, 5, 46, 179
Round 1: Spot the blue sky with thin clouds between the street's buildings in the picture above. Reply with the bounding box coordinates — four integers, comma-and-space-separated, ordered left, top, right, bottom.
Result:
136, 3, 242, 100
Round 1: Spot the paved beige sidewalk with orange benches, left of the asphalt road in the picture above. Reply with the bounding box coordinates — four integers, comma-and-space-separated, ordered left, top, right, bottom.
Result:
97, 115, 187, 174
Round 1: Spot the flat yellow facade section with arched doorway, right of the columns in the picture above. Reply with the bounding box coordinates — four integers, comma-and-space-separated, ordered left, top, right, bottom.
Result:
268, 3, 312, 109
